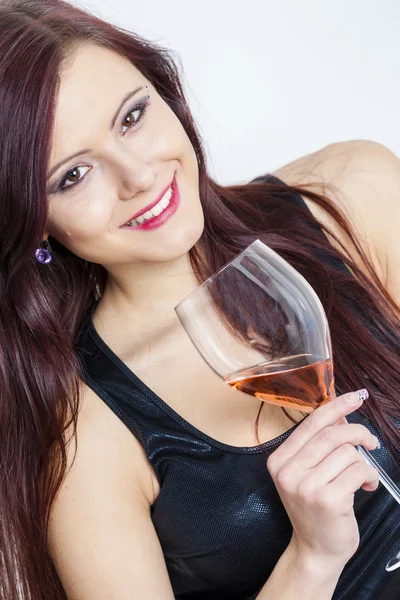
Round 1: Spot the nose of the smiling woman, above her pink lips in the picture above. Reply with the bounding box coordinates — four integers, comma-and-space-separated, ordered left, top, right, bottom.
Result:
113, 149, 156, 200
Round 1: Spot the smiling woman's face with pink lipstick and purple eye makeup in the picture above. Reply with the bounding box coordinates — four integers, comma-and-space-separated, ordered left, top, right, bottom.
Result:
47, 44, 204, 267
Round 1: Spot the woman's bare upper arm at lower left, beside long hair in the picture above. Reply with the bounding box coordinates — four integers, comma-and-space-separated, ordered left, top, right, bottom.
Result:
48, 385, 169, 600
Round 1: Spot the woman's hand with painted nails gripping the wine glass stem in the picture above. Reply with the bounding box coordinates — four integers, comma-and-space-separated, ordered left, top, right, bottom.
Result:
267, 392, 379, 569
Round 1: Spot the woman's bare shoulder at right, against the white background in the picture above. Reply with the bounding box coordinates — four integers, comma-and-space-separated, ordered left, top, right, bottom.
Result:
275, 140, 400, 298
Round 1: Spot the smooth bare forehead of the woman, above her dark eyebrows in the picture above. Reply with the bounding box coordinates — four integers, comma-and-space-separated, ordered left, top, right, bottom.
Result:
51, 44, 145, 164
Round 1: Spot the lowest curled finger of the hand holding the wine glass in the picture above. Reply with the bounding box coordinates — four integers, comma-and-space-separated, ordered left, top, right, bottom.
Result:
329, 461, 379, 514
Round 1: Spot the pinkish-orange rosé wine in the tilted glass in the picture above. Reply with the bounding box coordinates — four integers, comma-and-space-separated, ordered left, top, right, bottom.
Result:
225, 354, 334, 412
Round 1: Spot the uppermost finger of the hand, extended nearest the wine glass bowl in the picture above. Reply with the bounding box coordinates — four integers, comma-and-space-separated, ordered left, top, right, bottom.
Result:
268, 390, 368, 468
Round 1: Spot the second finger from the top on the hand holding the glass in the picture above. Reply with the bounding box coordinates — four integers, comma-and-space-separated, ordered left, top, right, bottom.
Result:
290, 423, 378, 472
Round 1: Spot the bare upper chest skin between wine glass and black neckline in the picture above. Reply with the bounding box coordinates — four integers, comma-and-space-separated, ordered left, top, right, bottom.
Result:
115, 332, 302, 447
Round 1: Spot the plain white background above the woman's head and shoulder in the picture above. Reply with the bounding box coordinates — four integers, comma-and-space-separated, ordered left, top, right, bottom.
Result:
70, 0, 400, 183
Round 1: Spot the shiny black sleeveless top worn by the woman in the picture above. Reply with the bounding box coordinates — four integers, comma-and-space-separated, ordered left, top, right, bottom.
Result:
78, 180, 400, 600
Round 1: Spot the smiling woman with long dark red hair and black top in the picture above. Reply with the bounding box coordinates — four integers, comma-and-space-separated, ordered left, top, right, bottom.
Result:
0, 0, 400, 600
